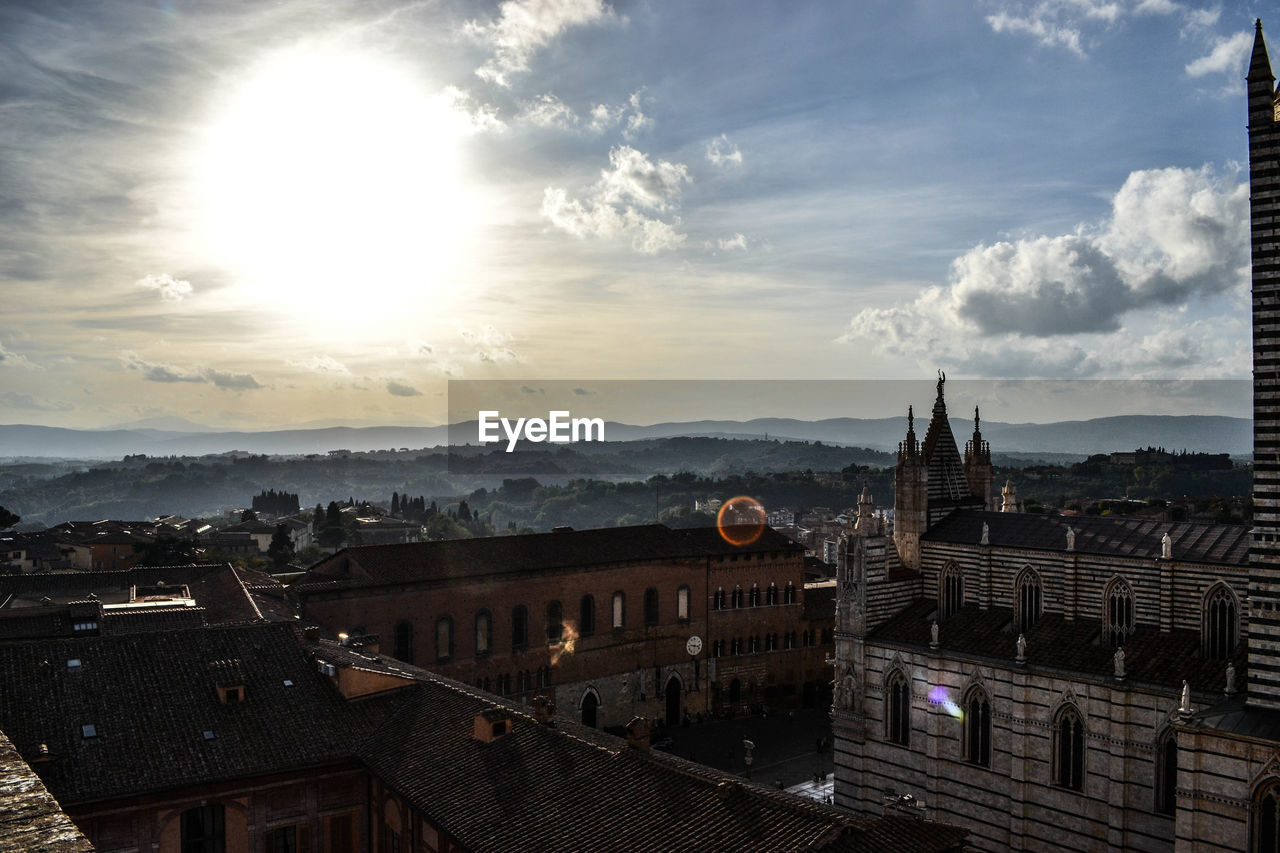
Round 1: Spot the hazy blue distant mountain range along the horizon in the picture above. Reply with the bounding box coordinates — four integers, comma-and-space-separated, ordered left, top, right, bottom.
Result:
0, 415, 1253, 460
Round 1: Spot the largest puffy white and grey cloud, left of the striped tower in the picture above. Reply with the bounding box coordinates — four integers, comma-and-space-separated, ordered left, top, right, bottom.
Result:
841, 168, 1248, 375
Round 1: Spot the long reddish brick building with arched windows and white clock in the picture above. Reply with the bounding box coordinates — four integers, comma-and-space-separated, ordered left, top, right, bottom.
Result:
291, 525, 833, 726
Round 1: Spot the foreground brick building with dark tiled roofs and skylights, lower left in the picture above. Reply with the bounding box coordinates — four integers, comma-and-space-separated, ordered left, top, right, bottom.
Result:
0, 612, 964, 853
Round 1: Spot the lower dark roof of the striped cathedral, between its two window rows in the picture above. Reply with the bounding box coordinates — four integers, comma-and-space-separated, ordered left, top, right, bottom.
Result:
870, 599, 1248, 695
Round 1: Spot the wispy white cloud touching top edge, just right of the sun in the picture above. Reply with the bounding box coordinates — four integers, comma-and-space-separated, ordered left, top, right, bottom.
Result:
465, 0, 612, 86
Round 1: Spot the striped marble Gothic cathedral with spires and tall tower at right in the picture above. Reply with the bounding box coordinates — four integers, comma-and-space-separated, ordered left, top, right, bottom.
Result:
832, 22, 1280, 853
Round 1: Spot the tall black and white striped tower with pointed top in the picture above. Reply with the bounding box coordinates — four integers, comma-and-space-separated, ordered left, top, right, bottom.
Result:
1247, 20, 1280, 708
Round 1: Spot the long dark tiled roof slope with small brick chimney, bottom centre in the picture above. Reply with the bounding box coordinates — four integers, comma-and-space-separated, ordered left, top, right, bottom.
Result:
361, 678, 965, 853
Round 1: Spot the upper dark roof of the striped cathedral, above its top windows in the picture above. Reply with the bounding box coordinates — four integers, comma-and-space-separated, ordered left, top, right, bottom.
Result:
920, 511, 1249, 566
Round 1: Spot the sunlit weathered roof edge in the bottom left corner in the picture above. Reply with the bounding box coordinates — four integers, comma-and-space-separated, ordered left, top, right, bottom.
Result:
0, 731, 93, 853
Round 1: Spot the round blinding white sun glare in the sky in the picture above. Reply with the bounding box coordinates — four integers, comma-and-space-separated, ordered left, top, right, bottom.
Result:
186, 46, 474, 326
